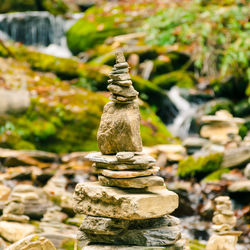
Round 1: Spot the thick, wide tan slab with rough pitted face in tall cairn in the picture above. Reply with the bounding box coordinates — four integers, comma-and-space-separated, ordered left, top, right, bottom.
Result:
74, 182, 178, 220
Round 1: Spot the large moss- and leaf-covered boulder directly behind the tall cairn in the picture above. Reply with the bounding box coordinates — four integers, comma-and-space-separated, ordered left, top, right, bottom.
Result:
0, 58, 172, 153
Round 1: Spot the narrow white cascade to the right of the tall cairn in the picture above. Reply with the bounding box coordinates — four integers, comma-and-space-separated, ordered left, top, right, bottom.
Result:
167, 86, 198, 139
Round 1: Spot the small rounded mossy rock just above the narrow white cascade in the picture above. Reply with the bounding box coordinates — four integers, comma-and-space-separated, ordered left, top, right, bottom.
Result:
153, 70, 195, 90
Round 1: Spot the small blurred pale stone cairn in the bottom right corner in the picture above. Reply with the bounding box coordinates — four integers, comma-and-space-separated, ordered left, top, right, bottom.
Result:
206, 196, 241, 250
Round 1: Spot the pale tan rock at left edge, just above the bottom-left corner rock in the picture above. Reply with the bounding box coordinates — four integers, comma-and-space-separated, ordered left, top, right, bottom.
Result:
0, 221, 35, 242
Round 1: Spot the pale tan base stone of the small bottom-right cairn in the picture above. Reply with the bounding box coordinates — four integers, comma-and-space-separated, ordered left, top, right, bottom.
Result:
206, 234, 238, 250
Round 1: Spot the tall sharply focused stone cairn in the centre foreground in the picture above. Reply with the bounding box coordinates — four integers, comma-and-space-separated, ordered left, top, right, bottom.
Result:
74, 51, 183, 250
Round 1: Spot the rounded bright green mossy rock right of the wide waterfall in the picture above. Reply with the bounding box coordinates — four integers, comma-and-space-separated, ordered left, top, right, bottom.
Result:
66, 6, 125, 55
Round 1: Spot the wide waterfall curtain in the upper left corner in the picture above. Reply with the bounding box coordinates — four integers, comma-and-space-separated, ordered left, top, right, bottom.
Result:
0, 11, 83, 57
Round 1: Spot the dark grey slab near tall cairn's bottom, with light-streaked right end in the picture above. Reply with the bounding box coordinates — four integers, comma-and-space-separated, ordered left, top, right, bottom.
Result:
81, 226, 181, 246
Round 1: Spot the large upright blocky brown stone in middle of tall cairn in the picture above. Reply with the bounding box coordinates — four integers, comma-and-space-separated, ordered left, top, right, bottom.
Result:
97, 102, 142, 154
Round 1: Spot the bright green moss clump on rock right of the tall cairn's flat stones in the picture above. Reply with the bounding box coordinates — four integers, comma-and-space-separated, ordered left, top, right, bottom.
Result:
177, 153, 223, 178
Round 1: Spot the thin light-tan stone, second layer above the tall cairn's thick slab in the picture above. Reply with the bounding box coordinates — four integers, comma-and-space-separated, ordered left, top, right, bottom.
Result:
102, 167, 160, 179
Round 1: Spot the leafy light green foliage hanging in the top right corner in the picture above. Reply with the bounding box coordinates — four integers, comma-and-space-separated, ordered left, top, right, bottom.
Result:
144, 1, 250, 88
